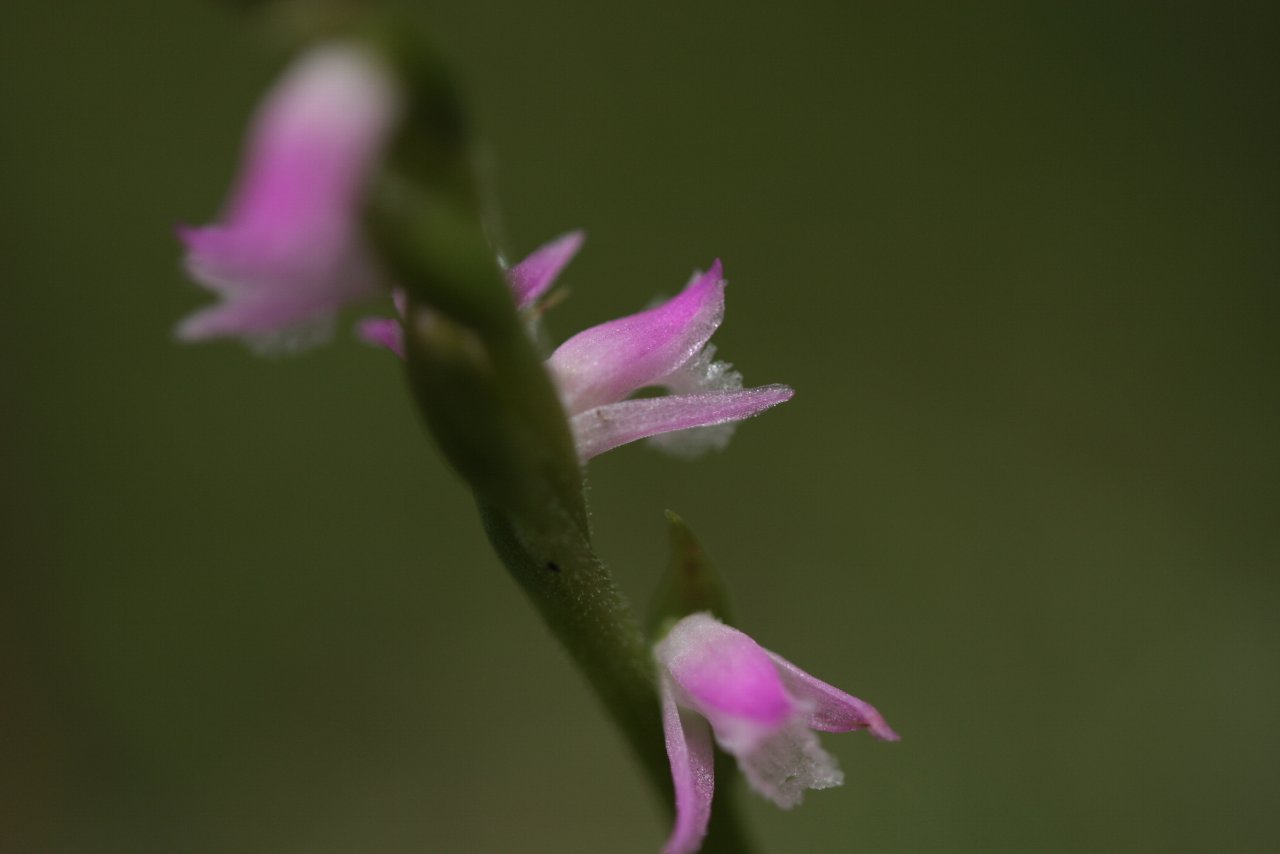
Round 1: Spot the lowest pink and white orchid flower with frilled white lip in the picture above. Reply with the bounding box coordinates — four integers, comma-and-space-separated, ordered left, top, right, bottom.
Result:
654, 613, 899, 854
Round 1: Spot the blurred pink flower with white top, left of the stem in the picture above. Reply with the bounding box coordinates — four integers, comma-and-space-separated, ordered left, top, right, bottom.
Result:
177, 44, 398, 346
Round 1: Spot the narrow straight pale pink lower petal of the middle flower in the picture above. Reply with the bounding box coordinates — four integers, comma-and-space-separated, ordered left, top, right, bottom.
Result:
570, 385, 795, 462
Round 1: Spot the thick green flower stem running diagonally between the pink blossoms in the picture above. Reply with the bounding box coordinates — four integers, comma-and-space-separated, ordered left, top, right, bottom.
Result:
367, 18, 748, 854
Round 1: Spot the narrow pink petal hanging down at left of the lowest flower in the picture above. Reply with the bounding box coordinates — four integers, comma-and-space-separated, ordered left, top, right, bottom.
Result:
662, 677, 716, 854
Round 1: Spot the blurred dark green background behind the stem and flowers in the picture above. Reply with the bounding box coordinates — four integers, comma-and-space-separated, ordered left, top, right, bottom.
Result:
0, 0, 1280, 854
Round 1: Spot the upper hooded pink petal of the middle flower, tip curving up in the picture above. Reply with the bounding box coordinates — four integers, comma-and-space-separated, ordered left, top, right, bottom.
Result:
548, 260, 724, 414
